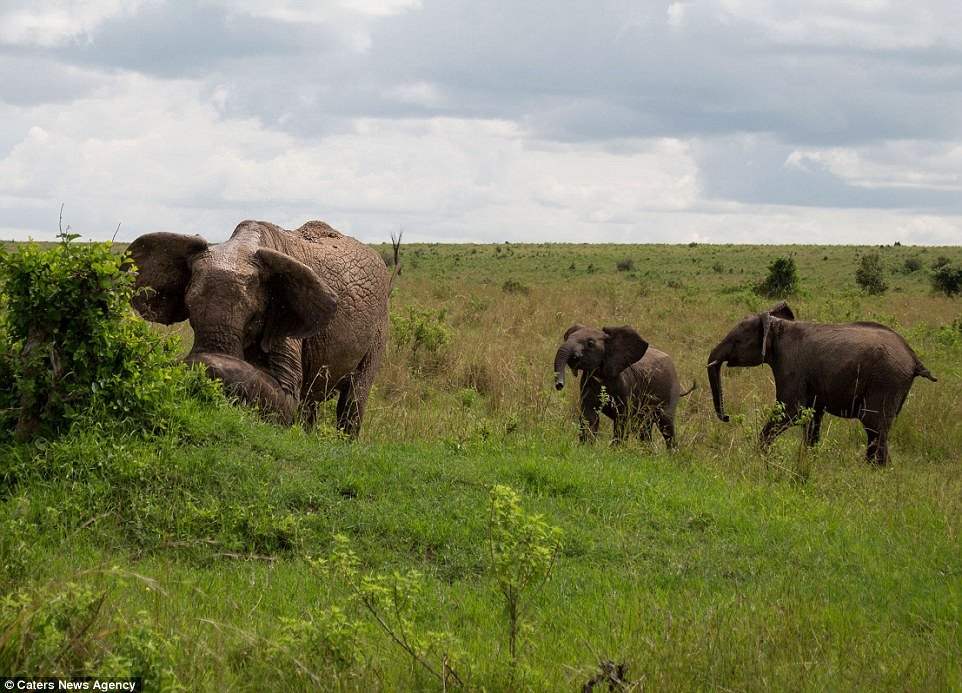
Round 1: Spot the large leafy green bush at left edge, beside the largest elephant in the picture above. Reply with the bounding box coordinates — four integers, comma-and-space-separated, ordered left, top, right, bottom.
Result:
0, 232, 217, 438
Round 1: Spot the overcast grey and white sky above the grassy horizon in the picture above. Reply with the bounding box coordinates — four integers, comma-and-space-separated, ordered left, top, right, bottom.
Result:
0, 0, 962, 244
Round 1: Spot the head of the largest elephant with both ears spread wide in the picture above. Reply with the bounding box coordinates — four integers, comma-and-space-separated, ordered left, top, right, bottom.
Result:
128, 222, 336, 359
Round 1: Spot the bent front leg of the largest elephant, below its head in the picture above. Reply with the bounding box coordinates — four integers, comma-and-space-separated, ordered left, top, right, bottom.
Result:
185, 353, 297, 424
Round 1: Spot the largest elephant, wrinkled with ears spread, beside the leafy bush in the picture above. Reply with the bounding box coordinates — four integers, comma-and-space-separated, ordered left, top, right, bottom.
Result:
129, 221, 398, 436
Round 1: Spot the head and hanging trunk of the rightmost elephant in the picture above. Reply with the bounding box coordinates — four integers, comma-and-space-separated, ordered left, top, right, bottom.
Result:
708, 301, 795, 421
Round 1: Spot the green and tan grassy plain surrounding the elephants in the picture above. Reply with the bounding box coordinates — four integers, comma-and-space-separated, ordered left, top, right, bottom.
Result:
0, 244, 962, 691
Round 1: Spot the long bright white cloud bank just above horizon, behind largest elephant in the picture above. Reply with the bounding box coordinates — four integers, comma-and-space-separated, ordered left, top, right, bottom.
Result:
0, 75, 697, 238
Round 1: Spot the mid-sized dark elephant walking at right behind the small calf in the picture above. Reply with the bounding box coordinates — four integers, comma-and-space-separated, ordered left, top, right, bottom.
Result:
708, 302, 937, 465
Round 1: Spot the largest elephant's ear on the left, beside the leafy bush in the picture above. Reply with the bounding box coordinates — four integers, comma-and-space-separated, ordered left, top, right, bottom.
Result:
126, 233, 207, 325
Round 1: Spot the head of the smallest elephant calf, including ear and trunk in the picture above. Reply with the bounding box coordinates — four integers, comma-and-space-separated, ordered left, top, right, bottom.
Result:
554, 325, 648, 390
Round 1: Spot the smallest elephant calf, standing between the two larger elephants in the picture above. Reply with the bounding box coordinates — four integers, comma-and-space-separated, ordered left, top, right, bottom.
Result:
554, 325, 695, 448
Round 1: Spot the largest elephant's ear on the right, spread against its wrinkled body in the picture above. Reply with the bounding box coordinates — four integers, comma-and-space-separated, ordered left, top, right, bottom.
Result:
256, 248, 337, 351
